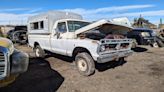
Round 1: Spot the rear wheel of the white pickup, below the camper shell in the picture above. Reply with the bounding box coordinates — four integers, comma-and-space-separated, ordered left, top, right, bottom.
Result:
34, 45, 45, 58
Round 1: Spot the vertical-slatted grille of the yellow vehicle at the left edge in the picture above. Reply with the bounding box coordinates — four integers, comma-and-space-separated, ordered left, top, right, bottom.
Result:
0, 52, 7, 78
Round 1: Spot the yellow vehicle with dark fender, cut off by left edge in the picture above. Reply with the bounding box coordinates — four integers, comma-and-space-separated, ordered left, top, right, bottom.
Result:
0, 37, 29, 87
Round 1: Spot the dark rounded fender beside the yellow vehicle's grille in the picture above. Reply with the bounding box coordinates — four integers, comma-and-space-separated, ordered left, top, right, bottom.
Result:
10, 50, 29, 74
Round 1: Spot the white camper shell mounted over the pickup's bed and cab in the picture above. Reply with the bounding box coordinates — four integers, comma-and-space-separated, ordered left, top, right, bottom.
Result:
28, 11, 82, 33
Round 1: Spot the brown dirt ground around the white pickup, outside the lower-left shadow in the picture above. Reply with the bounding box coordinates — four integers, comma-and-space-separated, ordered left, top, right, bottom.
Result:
2, 45, 164, 92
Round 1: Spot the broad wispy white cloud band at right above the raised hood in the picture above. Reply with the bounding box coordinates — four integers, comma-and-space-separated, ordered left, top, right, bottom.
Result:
63, 4, 164, 21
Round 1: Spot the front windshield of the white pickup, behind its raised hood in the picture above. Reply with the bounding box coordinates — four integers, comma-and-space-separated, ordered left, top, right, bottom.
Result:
67, 21, 90, 32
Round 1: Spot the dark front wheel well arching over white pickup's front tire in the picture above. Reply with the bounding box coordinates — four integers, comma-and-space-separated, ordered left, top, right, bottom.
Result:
72, 47, 92, 58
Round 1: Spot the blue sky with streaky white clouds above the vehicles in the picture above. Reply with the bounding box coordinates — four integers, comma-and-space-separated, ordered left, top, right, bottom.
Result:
0, 0, 164, 24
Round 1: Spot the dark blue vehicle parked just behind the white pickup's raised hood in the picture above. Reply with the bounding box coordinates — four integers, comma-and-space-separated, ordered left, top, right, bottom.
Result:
127, 28, 157, 45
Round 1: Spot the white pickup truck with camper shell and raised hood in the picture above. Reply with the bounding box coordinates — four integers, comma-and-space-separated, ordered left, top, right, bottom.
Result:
28, 11, 132, 76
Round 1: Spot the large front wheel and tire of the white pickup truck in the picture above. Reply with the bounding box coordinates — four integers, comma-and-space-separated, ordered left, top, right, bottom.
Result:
75, 52, 95, 76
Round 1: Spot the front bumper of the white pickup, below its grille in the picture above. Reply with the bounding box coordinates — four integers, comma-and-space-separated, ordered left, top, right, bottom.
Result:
97, 50, 133, 63
